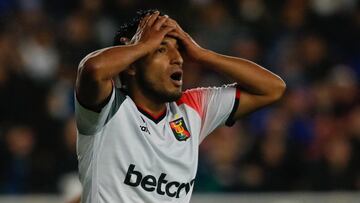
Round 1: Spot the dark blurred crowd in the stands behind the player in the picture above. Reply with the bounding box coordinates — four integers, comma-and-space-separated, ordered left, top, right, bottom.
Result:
0, 0, 360, 197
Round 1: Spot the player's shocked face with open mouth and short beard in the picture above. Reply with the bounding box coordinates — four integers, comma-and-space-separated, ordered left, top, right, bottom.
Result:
135, 37, 183, 102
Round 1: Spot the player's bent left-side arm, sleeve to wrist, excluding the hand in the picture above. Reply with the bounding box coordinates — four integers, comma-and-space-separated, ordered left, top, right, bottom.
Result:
75, 44, 148, 111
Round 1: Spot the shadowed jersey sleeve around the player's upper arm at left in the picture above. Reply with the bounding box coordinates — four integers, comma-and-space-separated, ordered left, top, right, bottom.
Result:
75, 87, 126, 135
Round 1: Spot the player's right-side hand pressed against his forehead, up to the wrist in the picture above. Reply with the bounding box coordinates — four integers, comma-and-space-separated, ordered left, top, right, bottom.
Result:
165, 18, 206, 62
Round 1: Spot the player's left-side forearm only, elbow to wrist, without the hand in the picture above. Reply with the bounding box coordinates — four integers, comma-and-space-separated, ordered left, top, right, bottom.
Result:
80, 43, 148, 80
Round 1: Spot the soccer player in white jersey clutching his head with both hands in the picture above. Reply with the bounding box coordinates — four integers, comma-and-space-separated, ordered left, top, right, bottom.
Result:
75, 11, 285, 203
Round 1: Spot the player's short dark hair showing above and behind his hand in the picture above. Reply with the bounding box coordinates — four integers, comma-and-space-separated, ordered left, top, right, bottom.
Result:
113, 9, 165, 46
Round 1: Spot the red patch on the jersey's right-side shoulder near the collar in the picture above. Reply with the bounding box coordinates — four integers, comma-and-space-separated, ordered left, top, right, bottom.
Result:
176, 89, 204, 118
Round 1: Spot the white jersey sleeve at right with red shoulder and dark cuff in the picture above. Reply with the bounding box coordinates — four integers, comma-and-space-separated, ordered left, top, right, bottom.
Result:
176, 84, 240, 141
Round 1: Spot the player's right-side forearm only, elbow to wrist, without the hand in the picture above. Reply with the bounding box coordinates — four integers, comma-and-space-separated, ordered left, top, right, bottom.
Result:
199, 50, 285, 96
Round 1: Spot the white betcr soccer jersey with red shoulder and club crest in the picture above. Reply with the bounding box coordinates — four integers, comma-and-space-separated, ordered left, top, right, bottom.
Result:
75, 85, 240, 203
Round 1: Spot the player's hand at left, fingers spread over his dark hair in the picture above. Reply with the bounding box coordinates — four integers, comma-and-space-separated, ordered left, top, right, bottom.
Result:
130, 11, 175, 52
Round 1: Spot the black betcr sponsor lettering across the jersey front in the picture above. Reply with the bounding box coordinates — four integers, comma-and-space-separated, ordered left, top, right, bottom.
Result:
124, 164, 195, 198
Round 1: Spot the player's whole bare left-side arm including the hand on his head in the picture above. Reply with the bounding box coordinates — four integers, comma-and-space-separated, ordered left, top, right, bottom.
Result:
75, 12, 173, 111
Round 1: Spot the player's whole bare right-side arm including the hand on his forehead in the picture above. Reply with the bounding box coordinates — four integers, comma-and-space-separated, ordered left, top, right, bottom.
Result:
169, 20, 286, 119
